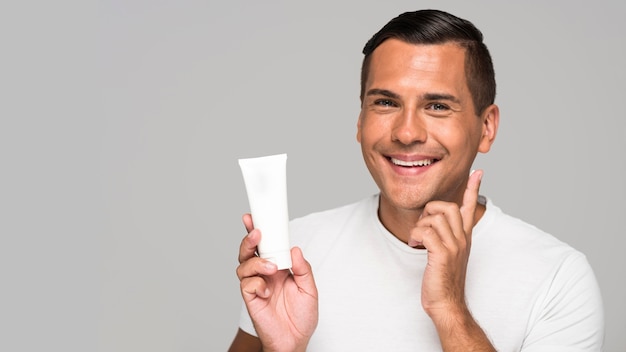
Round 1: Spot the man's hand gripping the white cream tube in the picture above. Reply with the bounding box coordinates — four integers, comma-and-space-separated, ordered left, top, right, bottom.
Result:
237, 214, 318, 351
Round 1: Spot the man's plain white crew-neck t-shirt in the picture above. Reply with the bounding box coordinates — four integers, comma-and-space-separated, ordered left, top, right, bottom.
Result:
240, 195, 604, 352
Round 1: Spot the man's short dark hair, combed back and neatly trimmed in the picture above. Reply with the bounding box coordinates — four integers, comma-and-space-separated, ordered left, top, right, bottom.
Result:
361, 10, 496, 115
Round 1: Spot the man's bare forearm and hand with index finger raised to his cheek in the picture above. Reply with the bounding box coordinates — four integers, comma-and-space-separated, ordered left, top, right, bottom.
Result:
409, 170, 495, 352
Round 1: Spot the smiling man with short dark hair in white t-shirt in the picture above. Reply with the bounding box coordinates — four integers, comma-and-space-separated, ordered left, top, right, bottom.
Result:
231, 10, 603, 352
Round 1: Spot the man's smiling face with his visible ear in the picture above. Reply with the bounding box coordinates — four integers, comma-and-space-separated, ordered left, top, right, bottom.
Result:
357, 39, 498, 210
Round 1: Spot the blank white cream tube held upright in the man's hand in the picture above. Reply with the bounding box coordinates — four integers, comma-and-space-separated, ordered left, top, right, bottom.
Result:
239, 154, 291, 270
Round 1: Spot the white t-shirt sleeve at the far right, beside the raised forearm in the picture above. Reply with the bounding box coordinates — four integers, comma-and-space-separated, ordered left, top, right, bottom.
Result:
522, 253, 604, 352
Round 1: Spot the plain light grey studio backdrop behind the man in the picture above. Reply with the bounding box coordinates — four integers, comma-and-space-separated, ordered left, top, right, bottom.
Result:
0, 0, 626, 352
